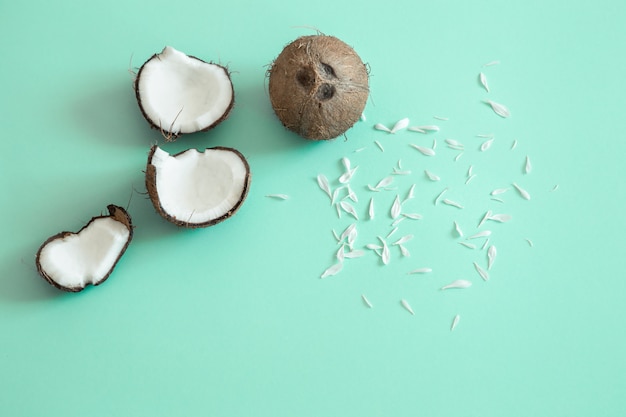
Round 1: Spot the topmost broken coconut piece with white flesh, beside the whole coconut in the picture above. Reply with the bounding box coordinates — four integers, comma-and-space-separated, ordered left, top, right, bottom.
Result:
135, 46, 235, 139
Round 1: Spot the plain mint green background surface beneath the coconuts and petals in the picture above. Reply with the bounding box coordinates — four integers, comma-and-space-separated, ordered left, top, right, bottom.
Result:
0, 0, 626, 417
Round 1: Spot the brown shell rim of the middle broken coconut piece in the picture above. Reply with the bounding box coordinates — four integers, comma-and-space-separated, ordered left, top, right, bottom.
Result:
145, 145, 252, 229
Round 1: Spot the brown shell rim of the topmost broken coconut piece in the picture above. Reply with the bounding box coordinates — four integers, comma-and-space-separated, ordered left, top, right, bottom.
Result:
133, 46, 235, 141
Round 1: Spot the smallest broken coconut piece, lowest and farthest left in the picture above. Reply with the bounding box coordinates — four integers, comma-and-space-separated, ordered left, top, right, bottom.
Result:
35, 205, 133, 292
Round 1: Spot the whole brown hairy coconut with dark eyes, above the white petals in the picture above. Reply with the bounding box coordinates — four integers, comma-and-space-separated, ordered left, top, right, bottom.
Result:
269, 35, 369, 140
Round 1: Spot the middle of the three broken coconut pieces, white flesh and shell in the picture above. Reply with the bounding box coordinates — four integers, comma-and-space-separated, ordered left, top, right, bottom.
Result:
146, 145, 250, 228
